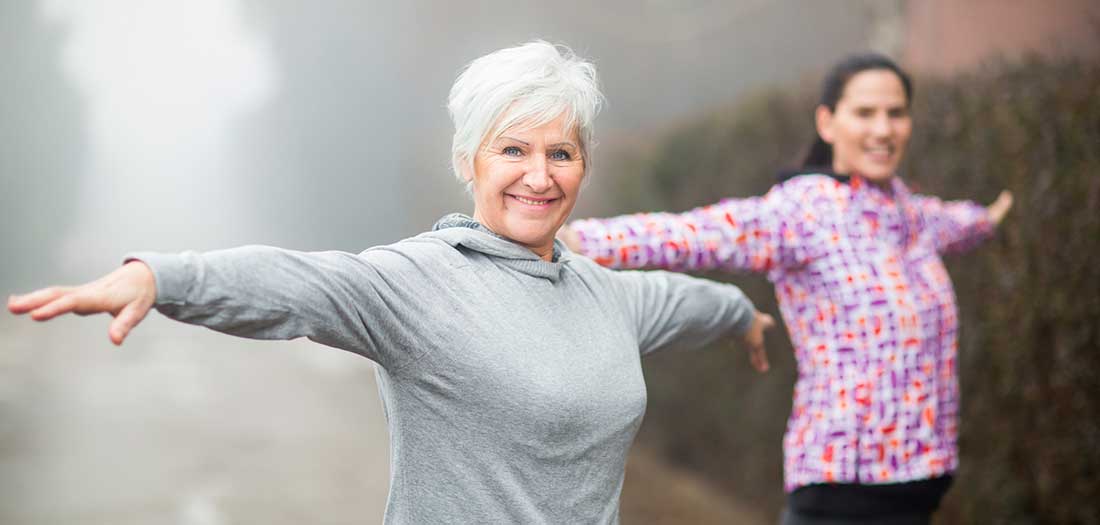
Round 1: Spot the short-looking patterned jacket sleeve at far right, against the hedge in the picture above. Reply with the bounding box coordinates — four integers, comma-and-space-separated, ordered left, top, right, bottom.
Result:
911, 195, 993, 254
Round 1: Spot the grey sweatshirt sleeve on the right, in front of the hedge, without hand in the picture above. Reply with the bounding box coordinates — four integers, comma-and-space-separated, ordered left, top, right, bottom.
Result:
614, 271, 756, 356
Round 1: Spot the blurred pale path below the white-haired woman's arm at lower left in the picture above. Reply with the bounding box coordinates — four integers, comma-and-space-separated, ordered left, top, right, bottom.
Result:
0, 314, 388, 525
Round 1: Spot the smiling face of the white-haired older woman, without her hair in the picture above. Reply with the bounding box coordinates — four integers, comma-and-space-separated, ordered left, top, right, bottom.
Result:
464, 116, 584, 261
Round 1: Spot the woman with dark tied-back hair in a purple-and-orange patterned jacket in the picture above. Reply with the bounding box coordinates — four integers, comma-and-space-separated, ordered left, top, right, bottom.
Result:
561, 54, 1012, 524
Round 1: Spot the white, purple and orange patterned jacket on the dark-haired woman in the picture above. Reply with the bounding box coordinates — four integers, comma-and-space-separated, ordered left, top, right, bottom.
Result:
571, 175, 992, 491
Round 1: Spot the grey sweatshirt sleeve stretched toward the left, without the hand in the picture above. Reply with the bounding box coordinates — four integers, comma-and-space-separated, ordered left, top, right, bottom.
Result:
127, 247, 433, 369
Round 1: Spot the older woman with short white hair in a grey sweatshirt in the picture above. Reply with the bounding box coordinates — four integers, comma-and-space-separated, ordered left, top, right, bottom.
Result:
8, 42, 772, 523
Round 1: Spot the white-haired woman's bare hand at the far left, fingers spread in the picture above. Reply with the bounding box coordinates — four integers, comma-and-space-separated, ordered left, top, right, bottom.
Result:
8, 261, 156, 344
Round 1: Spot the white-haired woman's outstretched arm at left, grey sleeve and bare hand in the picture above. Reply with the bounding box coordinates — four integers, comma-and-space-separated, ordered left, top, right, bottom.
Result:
9, 247, 424, 367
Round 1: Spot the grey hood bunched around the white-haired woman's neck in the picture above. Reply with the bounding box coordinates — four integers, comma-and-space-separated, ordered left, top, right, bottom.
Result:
428, 214, 571, 283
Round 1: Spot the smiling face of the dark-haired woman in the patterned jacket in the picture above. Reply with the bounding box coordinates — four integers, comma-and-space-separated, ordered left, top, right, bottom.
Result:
816, 69, 913, 183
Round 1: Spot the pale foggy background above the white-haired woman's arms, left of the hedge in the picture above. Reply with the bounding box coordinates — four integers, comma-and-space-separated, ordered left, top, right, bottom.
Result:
0, 0, 868, 281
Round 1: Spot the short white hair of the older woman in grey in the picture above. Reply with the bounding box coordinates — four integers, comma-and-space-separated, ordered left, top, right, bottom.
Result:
447, 41, 603, 183
